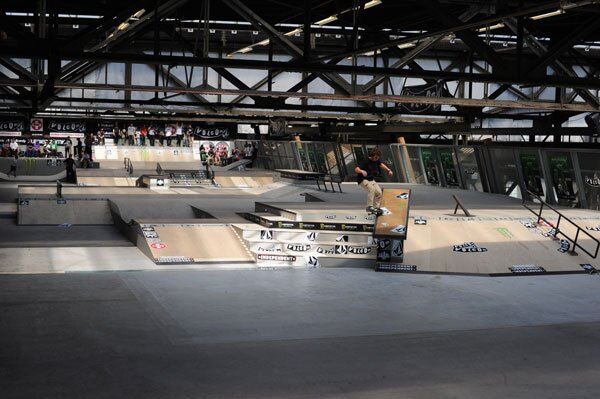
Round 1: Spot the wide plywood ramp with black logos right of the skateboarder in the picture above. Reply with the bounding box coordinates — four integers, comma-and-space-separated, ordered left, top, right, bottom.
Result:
404, 220, 597, 274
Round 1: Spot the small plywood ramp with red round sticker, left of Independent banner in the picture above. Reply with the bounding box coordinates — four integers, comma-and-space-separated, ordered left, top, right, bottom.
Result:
150, 225, 254, 262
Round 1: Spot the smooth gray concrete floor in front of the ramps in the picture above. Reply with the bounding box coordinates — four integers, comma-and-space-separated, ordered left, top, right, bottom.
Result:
0, 269, 600, 399
